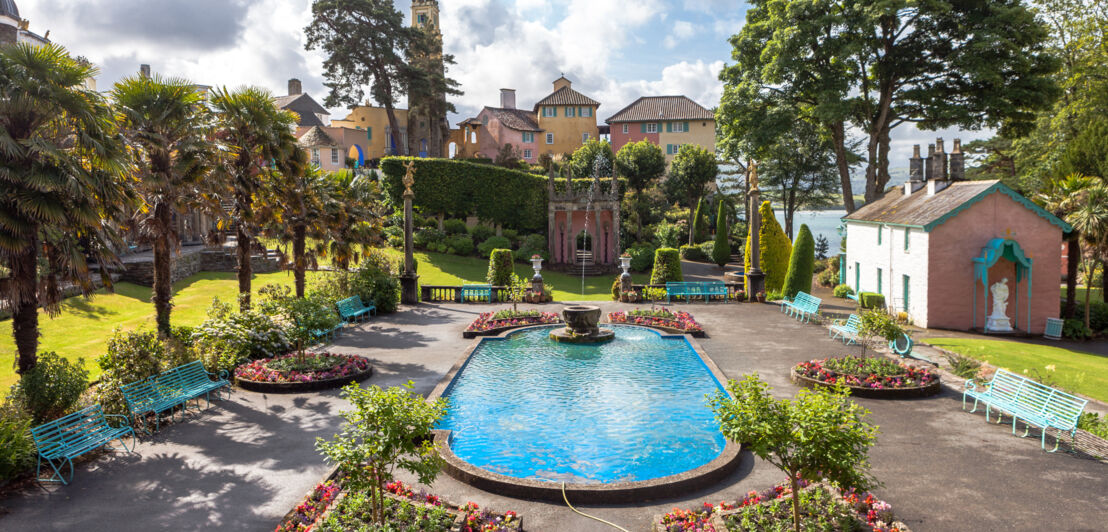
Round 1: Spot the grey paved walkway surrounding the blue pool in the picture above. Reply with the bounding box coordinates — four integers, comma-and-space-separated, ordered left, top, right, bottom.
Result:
0, 304, 1108, 532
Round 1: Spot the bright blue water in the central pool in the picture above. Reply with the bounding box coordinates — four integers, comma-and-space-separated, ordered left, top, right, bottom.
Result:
439, 326, 725, 482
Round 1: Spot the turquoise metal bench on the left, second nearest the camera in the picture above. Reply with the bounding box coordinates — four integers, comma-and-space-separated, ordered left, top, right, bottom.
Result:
121, 360, 230, 430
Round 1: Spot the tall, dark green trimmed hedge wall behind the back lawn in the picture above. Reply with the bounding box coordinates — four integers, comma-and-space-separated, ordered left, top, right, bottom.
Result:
381, 157, 624, 232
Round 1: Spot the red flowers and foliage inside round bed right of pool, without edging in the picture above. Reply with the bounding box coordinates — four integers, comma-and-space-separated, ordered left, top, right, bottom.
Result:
793, 356, 938, 390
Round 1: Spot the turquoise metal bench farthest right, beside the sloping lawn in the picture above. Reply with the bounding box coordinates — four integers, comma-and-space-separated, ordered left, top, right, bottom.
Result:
962, 369, 1089, 452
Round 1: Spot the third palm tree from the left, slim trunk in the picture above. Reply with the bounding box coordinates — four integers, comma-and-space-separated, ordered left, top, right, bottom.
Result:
212, 88, 298, 310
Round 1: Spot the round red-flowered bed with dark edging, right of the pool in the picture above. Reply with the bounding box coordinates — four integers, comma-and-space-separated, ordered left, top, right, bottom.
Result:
792, 356, 940, 398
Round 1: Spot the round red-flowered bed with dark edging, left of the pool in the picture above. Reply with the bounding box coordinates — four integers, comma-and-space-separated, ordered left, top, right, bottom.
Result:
235, 352, 373, 393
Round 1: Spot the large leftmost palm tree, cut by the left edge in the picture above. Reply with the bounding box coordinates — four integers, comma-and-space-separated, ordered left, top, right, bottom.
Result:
0, 43, 132, 375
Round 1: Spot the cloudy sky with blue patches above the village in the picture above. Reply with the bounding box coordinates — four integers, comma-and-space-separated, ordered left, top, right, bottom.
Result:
17, 0, 981, 166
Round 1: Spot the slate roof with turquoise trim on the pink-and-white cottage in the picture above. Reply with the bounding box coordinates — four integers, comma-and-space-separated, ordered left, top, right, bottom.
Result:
843, 180, 1071, 233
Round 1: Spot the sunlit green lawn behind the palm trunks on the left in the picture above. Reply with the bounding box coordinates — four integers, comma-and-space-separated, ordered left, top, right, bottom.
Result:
0, 272, 308, 392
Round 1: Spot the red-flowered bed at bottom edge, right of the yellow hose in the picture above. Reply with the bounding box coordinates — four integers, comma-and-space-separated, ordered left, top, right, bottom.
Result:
653, 481, 910, 532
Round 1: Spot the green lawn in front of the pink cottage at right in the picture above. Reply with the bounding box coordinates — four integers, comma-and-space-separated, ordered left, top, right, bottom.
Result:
926, 338, 1108, 401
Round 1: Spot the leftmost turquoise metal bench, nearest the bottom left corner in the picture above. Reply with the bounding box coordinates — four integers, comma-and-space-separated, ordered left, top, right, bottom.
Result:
31, 405, 135, 484
